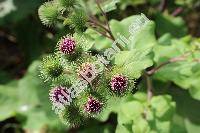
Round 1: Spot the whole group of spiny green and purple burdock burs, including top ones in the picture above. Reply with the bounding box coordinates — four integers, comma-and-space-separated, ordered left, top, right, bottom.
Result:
39, 0, 134, 126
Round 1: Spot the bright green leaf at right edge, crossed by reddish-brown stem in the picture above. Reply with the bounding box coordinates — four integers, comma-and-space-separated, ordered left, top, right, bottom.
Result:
154, 35, 200, 99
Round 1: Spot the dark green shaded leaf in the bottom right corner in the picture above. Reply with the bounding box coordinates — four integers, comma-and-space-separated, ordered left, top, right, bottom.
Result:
153, 80, 200, 133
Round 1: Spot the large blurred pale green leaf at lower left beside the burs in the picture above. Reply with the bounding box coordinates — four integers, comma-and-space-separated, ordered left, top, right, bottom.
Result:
0, 61, 65, 132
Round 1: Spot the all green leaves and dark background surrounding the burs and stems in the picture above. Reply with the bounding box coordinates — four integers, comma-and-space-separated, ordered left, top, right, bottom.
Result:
0, 0, 200, 133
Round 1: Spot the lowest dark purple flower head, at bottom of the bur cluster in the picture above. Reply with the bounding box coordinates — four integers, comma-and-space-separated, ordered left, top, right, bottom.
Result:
85, 96, 103, 114
